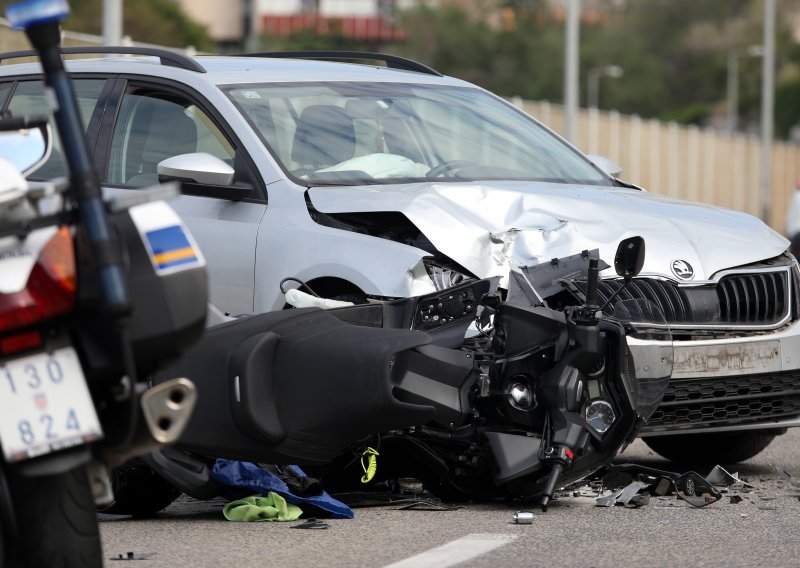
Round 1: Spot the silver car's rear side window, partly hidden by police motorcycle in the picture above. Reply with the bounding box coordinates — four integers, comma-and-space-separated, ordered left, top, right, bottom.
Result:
6, 79, 106, 179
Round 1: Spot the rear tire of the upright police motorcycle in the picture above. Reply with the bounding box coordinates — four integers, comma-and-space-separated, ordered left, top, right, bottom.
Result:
4, 466, 103, 568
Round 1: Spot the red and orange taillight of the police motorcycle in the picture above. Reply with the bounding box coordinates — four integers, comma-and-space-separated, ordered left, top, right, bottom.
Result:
0, 227, 76, 331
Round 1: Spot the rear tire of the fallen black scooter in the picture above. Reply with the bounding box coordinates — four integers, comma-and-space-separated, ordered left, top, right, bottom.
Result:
98, 458, 181, 517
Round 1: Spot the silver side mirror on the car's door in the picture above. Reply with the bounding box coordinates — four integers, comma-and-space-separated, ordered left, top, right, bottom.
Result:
156, 152, 253, 201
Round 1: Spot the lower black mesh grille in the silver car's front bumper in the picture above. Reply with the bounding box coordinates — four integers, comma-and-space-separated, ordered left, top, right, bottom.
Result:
644, 371, 800, 432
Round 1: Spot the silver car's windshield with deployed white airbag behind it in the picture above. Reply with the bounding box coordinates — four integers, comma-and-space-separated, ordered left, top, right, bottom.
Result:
224, 82, 612, 185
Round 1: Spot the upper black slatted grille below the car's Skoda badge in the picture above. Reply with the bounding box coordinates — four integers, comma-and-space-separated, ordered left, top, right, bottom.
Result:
598, 267, 791, 329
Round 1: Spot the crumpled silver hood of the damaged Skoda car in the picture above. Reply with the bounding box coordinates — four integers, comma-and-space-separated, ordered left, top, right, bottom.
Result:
309, 182, 788, 282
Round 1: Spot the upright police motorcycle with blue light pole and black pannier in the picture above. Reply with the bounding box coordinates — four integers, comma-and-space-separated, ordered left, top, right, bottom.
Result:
0, 1, 207, 567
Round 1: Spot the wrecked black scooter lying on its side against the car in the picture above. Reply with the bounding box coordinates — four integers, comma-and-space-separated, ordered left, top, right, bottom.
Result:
119, 237, 672, 515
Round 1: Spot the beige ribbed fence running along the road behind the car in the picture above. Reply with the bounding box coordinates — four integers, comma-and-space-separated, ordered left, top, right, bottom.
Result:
0, 20, 800, 233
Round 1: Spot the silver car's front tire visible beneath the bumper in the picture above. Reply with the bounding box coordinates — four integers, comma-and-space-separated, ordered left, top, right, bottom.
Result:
642, 430, 776, 465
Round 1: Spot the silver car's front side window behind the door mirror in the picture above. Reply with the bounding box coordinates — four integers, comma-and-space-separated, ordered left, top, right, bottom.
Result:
104, 90, 236, 187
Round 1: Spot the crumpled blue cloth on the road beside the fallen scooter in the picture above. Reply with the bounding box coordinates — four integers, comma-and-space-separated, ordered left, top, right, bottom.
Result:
211, 459, 354, 519
